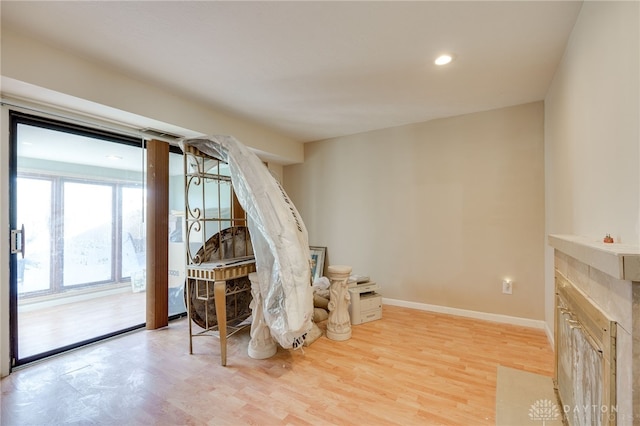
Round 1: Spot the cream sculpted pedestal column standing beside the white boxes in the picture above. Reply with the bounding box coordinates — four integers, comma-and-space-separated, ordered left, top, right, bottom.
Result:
327, 265, 351, 341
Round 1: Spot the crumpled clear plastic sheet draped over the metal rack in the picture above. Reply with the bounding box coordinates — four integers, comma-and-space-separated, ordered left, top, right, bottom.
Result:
180, 136, 313, 349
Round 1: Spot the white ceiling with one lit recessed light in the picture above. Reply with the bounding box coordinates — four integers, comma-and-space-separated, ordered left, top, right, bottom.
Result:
1, 0, 582, 142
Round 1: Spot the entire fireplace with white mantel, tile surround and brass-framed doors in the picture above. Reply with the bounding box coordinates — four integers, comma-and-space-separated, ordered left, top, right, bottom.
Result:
549, 235, 640, 425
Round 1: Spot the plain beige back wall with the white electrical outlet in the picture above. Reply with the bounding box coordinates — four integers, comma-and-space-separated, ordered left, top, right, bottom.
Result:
284, 102, 545, 320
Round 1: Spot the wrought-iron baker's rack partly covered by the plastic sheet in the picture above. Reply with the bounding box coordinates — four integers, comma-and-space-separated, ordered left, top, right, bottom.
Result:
183, 145, 256, 365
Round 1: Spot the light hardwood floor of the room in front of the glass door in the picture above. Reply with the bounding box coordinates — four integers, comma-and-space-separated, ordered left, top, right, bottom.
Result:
0, 306, 553, 425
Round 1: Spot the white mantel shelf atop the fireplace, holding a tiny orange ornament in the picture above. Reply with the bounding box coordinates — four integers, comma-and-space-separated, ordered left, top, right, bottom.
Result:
549, 235, 640, 281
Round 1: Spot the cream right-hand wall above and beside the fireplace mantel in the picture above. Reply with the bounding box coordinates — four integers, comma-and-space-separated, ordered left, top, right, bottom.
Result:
545, 1, 640, 326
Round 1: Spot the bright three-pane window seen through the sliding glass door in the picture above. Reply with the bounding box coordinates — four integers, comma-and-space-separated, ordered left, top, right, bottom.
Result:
17, 174, 145, 297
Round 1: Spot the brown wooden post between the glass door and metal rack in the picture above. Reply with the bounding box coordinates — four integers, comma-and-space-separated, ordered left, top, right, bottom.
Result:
146, 140, 169, 330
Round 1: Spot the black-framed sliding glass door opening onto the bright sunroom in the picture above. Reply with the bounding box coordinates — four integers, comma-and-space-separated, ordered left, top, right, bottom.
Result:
10, 113, 146, 365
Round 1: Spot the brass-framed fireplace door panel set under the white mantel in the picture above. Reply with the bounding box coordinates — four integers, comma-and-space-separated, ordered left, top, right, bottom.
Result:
555, 273, 618, 425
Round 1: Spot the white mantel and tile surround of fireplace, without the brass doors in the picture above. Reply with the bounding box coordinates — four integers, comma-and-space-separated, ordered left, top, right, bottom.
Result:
549, 235, 640, 425
